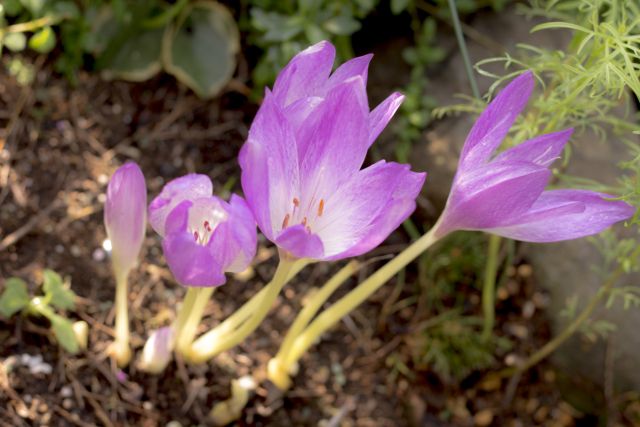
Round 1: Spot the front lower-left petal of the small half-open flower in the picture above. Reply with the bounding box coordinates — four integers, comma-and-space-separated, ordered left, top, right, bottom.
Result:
162, 200, 226, 287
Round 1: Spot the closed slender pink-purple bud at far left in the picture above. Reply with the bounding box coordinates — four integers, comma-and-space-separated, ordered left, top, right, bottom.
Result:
104, 162, 147, 275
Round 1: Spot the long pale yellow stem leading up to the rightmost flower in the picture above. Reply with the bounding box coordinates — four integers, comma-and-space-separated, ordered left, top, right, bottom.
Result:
285, 227, 441, 367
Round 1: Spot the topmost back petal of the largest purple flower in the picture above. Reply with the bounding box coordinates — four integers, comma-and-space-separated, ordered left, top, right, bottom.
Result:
273, 41, 336, 108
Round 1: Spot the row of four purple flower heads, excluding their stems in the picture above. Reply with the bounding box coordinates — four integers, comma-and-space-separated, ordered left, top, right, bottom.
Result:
105, 42, 634, 378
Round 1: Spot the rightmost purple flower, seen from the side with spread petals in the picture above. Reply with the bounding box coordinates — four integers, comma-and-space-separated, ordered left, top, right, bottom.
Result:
435, 72, 634, 242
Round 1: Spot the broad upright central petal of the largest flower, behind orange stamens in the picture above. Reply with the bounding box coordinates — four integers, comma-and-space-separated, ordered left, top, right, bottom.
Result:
297, 77, 369, 199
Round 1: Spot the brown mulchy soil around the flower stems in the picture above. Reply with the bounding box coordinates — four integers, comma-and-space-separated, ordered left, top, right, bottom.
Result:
0, 18, 632, 427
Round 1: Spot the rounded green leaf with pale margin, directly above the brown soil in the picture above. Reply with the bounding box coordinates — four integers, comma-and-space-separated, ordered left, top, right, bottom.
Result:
162, 1, 240, 98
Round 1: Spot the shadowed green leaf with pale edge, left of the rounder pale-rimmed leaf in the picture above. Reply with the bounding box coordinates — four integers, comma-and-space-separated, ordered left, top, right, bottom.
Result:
103, 29, 164, 82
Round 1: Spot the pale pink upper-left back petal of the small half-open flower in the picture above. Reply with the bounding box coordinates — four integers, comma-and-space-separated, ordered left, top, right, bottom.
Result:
149, 173, 213, 236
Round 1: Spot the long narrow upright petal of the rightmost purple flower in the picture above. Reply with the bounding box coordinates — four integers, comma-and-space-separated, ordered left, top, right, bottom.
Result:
458, 71, 534, 171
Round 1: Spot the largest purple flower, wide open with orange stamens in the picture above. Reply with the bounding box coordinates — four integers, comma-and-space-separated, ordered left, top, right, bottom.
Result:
240, 42, 426, 260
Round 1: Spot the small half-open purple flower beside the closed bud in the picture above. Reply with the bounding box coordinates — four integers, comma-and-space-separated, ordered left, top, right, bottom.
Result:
149, 174, 257, 286
